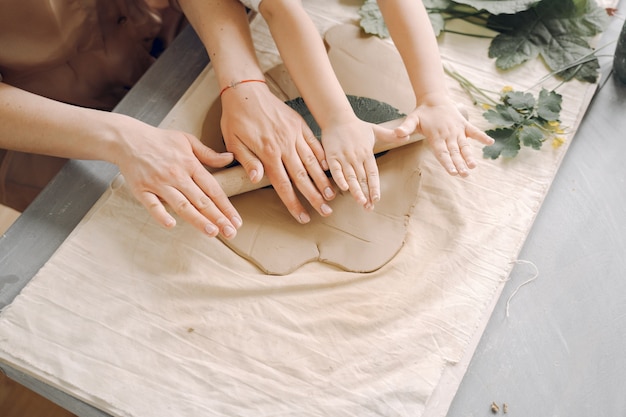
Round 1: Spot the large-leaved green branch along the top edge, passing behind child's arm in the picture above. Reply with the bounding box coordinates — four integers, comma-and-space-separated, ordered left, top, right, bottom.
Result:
359, 0, 608, 82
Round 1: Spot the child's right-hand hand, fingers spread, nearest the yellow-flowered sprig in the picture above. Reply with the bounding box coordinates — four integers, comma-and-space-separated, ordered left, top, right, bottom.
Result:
394, 101, 494, 177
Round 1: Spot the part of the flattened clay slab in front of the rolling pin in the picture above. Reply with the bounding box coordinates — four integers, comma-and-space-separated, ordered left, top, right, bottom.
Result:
223, 143, 421, 275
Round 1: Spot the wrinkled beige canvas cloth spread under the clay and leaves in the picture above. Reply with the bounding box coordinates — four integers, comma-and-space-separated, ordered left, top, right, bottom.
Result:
0, 0, 595, 417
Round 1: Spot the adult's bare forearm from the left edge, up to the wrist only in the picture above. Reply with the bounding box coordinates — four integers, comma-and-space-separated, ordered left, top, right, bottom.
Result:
0, 82, 125, 162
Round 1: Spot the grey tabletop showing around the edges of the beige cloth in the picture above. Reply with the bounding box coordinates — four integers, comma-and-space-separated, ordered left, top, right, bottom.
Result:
0, 7, 626, 417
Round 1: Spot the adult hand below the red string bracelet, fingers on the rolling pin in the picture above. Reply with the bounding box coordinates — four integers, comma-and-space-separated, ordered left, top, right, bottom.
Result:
221, 83, 335, 223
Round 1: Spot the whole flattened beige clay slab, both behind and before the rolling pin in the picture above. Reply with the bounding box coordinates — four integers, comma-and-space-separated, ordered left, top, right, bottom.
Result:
204, 25, 422, 275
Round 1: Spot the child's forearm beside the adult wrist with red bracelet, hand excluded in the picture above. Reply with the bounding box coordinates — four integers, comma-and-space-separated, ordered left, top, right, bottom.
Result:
261, 0, 355, 129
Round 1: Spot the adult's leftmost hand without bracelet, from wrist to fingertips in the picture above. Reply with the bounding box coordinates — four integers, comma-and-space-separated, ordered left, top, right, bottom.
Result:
112, 114, 242, 238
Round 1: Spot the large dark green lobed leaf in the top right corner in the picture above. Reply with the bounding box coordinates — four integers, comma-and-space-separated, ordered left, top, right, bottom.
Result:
487, 0, 608, 82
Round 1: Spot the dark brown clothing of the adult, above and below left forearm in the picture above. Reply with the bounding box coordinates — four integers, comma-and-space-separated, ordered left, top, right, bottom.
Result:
0, 0, 183, 210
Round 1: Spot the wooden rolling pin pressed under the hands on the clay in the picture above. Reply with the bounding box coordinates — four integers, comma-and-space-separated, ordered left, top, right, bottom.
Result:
213, 119, 424, 197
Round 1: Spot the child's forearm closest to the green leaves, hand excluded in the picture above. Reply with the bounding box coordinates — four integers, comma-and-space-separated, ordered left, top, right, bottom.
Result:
378, 0, 447, 105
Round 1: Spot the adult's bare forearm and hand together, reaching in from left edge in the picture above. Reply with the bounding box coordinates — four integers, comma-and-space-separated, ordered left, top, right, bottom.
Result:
0, 78, 241, 238
